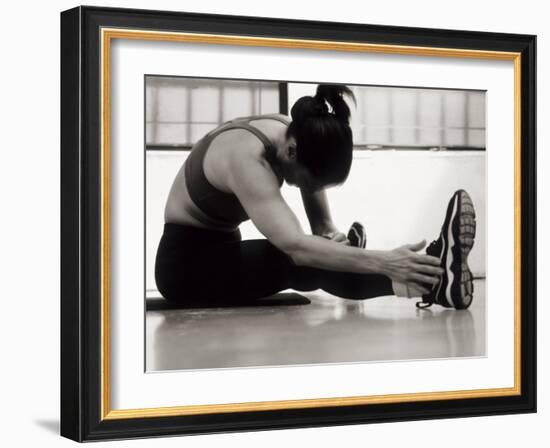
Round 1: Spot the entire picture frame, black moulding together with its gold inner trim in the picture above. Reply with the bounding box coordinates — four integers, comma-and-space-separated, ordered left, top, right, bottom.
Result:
60, 6, 536, 442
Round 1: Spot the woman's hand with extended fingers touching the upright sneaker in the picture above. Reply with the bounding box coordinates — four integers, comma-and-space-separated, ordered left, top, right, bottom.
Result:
383, 240, 443, 286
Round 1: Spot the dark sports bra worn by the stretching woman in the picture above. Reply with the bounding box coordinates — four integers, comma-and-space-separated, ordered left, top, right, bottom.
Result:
184, 114, 290, 227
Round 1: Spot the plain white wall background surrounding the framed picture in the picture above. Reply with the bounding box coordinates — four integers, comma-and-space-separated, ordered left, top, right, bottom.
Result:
0, 0, 550, 448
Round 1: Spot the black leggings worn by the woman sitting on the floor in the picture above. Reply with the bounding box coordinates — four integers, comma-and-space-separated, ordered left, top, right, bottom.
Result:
155, 223, 394, 305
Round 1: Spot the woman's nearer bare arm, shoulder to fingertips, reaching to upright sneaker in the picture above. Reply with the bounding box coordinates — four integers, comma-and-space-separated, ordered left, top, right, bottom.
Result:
228, 153, 442, 284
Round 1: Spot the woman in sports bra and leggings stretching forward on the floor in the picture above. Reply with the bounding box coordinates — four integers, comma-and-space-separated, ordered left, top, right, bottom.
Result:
155, 85, 475, 308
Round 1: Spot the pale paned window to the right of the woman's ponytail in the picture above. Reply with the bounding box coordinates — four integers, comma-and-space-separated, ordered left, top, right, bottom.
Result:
351, 86, 485, 150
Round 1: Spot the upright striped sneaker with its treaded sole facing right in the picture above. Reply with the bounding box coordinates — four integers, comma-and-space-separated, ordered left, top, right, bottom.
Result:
416, 190, 476, 309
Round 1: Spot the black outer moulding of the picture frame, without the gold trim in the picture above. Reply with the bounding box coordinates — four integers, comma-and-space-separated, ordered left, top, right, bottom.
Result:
60, 7, 536, 441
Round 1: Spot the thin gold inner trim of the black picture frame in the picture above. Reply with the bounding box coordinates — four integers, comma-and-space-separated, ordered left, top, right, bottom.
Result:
100, 28, 521, 420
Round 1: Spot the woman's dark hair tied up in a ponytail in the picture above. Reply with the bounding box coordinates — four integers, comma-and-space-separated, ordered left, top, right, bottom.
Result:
287, 84, 357, 184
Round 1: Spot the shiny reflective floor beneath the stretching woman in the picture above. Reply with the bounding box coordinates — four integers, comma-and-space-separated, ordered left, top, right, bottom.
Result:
146, 280, 486, 371
